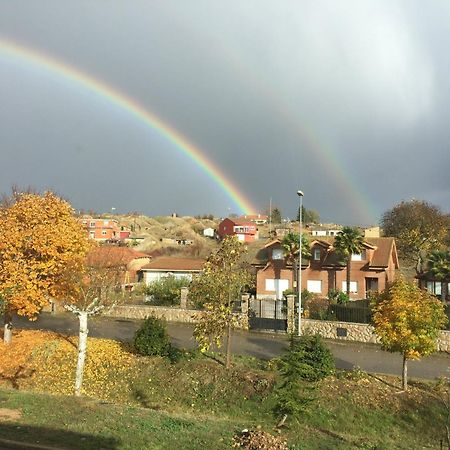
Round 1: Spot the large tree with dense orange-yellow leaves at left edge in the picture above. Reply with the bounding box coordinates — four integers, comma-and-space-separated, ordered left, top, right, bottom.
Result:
0, 191, 89, 343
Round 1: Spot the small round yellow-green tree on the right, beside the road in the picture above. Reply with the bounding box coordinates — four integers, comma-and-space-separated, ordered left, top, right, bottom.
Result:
372, 278, 447, 391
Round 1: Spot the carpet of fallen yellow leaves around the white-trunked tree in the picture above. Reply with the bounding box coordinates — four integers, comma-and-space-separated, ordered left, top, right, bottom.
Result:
0, 331, 137, 401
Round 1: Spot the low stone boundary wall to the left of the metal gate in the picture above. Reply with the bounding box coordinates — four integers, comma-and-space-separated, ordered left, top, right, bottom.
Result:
104, 305, 248, 328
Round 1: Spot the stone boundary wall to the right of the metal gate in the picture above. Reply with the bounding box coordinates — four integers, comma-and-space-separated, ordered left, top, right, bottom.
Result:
302, 319, 450, 352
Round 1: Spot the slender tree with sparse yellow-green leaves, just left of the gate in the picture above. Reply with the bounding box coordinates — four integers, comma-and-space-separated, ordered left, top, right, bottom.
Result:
189, 236, 251, 368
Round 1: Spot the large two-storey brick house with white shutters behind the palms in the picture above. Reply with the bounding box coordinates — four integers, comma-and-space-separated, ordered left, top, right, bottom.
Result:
254, 237, 399, 299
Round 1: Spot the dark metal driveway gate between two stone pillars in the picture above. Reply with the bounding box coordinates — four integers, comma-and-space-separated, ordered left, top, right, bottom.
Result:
248, 299, 287, 332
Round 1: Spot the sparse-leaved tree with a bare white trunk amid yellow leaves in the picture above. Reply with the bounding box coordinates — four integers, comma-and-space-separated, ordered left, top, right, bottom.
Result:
65, 252, 123, 396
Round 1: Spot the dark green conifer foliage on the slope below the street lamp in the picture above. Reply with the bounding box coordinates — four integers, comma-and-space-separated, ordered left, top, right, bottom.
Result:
275, 335, 335, 416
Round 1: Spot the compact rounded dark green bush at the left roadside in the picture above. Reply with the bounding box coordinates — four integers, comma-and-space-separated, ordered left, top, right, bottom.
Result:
133, 317, 172, 356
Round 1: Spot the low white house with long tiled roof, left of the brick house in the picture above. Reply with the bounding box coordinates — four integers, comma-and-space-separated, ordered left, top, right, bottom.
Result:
138, 256, 206, 284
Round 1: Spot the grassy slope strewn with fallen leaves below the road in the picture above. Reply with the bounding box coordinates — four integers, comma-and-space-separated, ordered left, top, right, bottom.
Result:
0, 331, 446, 450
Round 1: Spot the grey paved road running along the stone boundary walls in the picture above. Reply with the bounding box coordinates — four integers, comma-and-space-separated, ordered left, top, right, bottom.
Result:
14, 313, 450, 379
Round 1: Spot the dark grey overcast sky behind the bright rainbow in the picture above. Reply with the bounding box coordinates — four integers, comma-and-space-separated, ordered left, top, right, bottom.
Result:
0, 0, 450, 225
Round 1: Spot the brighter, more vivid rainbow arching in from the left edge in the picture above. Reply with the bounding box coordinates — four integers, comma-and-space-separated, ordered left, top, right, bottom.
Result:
0, 37, 257, 214
